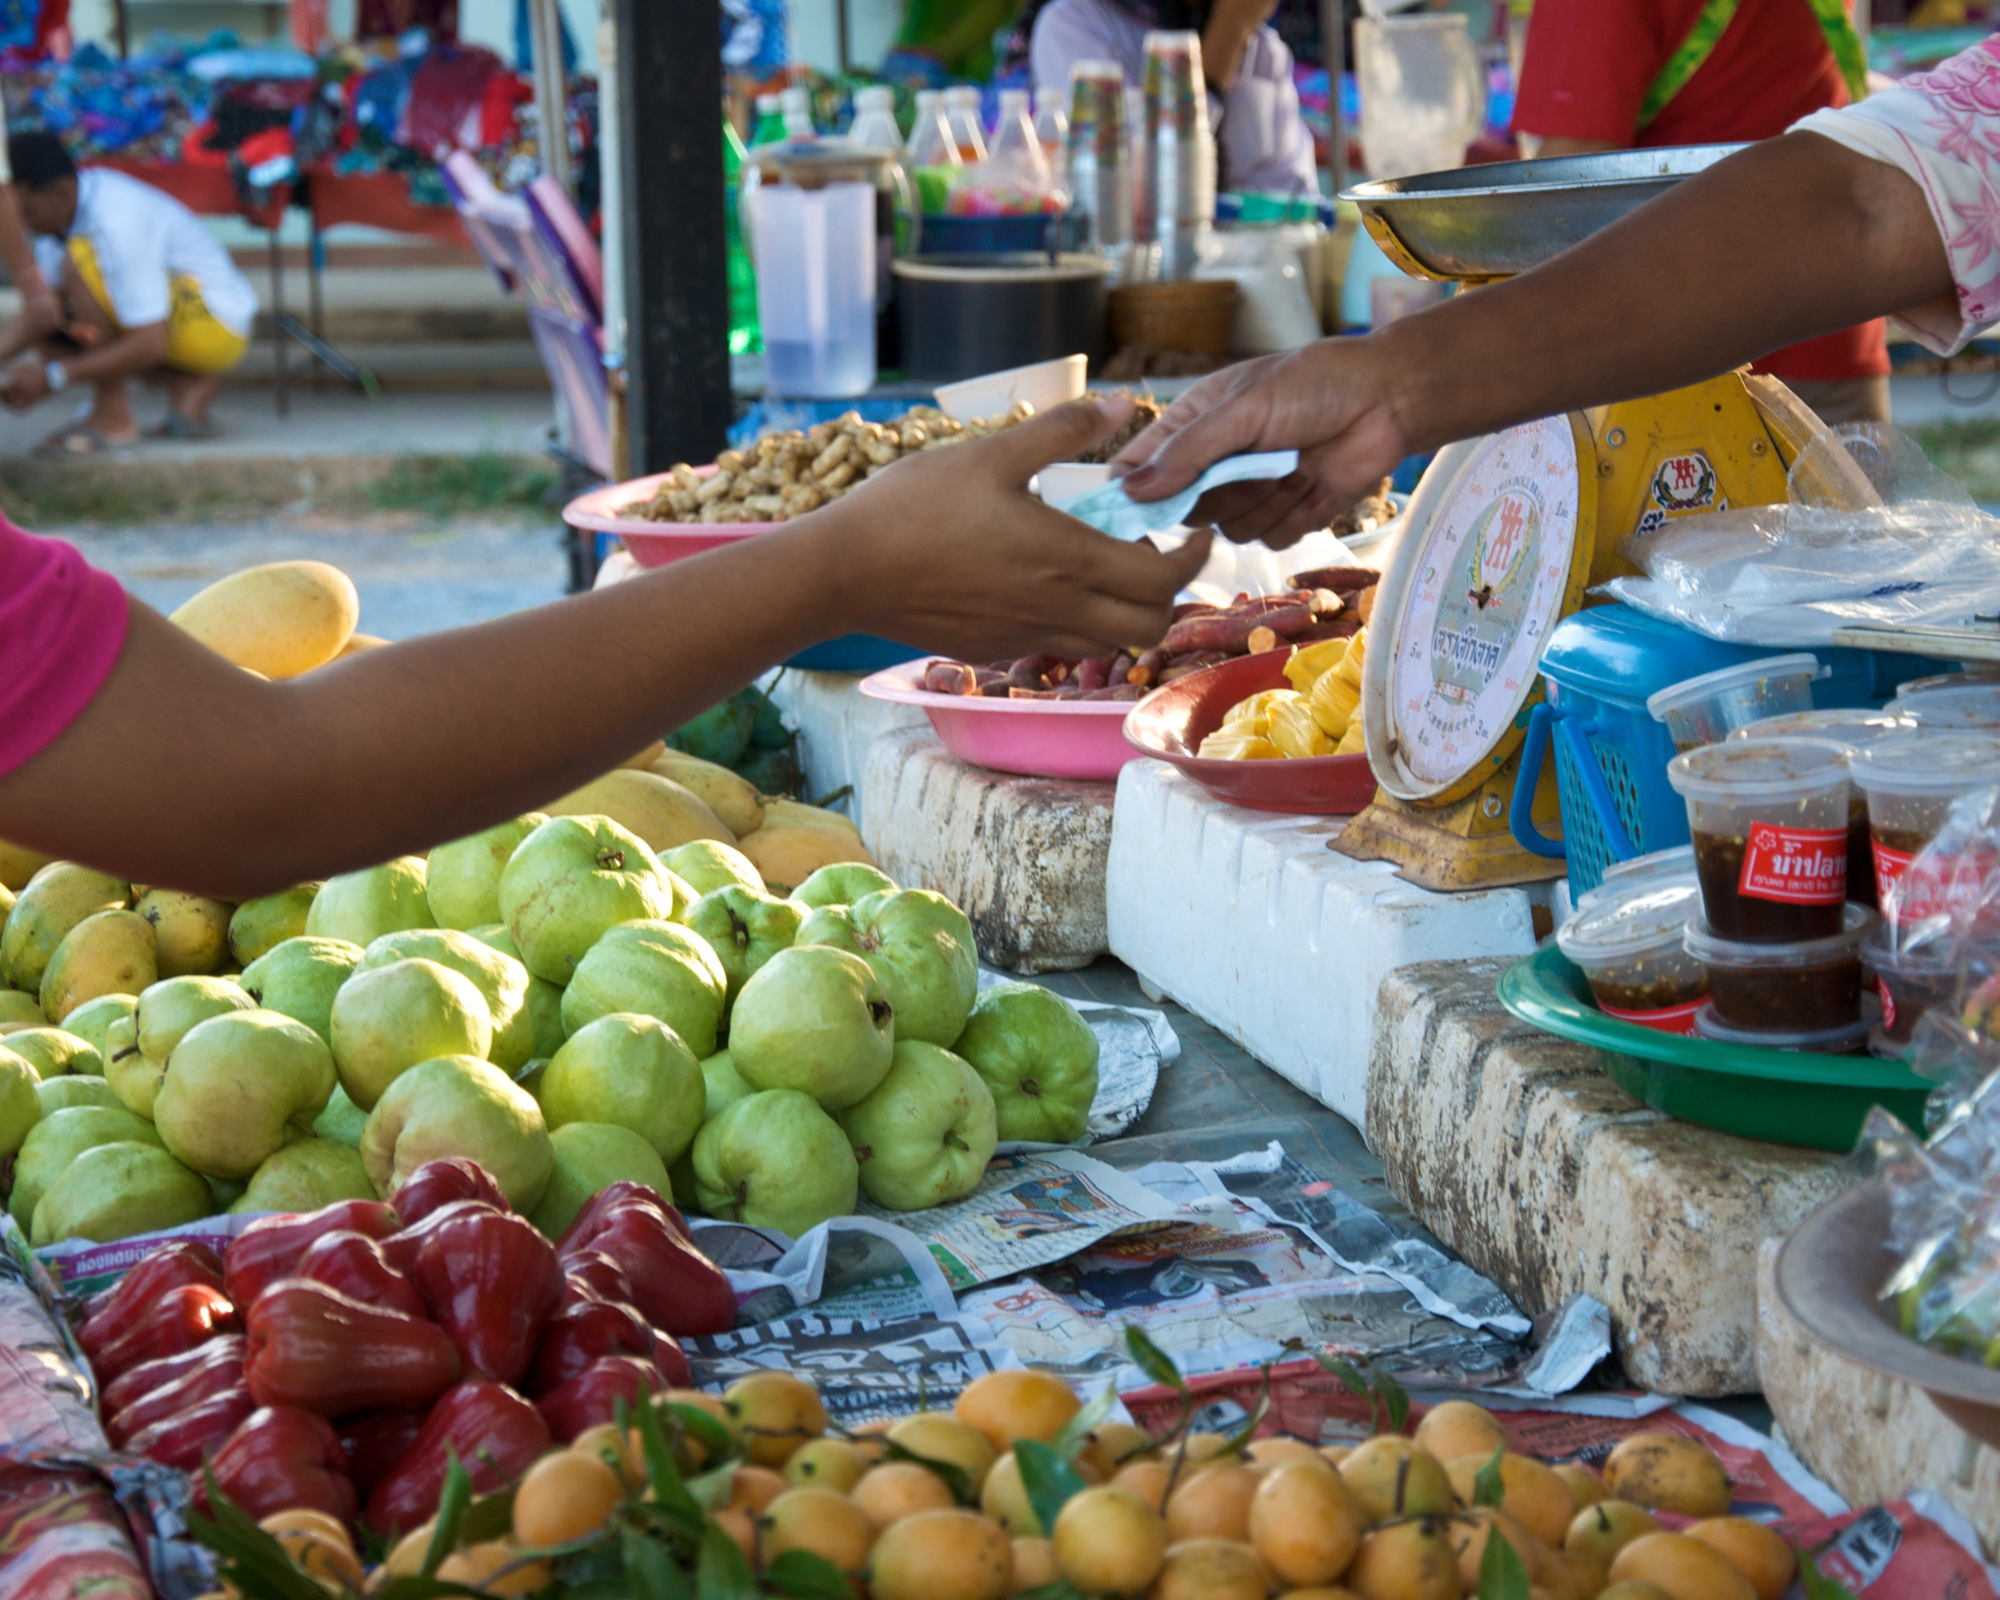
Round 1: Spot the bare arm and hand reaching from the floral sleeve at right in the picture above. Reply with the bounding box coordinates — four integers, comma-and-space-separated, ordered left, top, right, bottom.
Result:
1118, 134, 1954, 542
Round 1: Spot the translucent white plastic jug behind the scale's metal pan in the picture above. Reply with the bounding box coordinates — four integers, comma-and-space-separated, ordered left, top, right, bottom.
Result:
1354, 12, 1486, 178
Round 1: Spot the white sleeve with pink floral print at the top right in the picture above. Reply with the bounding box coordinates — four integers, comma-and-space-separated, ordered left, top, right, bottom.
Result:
1792, 38, 2000, 356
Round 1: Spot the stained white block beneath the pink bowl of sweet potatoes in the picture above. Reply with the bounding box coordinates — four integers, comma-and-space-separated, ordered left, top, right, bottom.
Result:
860, 726, 1112, 972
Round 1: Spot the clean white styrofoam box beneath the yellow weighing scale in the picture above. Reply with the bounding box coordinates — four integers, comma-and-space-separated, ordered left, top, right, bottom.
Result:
1104, 760, 1550, 1126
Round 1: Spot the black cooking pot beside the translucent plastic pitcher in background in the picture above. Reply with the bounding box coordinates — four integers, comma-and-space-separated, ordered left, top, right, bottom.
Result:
890, 254, 1106, 384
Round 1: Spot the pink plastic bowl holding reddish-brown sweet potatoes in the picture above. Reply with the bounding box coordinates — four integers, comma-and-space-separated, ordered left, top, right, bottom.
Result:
862, 658, 1138, 784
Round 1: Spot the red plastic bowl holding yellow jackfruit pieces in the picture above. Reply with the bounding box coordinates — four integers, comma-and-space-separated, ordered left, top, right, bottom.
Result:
1124, 650, 1376, 816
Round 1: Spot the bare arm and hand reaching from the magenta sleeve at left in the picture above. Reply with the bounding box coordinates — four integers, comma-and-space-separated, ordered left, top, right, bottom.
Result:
0, 402, 1206, 900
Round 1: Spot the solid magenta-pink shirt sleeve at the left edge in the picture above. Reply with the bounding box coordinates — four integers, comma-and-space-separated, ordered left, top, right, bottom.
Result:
0, 516, 126, 774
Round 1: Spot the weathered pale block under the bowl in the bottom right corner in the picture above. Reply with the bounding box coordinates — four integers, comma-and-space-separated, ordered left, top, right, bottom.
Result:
1756, 1240, 2000, 1552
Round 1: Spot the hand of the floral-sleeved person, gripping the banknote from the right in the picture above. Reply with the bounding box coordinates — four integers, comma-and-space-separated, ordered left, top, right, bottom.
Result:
1112, 336, 1408, 550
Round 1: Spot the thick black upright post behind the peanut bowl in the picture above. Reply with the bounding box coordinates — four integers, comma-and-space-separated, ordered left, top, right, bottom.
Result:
606, 0, 730, 472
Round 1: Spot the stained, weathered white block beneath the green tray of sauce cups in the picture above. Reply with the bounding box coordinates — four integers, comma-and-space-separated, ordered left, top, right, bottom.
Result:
1366, 960, 1848, 1396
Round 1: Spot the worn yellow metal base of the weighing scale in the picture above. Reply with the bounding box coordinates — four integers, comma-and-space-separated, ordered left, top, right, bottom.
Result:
1326, 752, 1568, 894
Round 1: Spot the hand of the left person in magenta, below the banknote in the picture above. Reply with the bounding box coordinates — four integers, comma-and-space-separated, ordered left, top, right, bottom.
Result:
796, 396, 1208, 662
